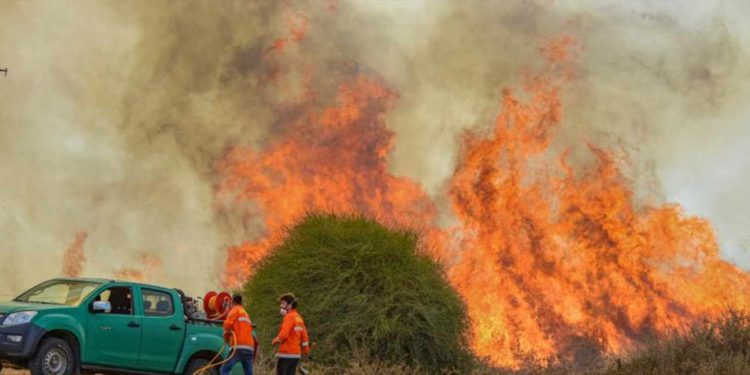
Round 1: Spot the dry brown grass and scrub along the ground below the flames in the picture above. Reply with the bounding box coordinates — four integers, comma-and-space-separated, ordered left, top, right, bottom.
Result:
2, 313, 750, 375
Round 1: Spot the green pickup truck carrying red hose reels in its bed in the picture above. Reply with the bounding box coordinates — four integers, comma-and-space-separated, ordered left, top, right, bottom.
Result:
0, 278, 241, 375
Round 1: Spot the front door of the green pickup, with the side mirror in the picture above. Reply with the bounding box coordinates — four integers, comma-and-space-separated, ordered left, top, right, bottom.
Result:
86, 286, 142, 368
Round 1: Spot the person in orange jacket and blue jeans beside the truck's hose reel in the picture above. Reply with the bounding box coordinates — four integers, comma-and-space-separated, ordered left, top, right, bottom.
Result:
221, 294, 257, 375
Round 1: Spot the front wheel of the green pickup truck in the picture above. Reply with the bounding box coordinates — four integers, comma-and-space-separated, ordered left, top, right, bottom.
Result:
29, 337, 78, 375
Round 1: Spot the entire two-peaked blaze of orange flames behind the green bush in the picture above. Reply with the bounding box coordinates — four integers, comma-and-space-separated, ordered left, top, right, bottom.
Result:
217, 10, 750, 368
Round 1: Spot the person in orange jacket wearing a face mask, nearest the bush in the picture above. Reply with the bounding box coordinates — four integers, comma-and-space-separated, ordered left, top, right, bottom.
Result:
272, 293, 310, 375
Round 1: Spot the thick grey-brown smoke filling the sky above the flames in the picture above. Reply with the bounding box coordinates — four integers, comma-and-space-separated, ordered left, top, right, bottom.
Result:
0, 0, 750, 293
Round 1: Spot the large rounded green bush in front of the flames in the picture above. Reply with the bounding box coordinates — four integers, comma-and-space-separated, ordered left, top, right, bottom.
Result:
244, 215, 471, 371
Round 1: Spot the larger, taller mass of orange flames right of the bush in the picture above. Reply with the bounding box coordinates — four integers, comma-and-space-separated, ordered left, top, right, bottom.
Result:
450, 39, 750, 368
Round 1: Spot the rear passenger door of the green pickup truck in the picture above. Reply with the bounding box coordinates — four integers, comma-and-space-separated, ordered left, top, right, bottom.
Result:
138, 287, 185, 372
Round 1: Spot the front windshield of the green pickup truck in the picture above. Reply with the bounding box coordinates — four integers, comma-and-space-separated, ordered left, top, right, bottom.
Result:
14, 280, 102, 306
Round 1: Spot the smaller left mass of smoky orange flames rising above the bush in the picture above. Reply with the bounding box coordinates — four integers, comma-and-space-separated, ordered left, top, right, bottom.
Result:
218, 76, 436, 287
